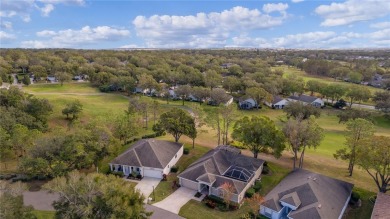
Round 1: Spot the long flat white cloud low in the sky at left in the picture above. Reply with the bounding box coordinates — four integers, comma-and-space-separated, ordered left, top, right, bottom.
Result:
21, 26, 130, 48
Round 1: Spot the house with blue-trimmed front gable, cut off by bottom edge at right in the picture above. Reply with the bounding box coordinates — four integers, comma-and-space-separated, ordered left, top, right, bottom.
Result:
260, 169, 353, 219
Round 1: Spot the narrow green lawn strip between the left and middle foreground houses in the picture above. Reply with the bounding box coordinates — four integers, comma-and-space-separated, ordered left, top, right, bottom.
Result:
150, 145, 210, 202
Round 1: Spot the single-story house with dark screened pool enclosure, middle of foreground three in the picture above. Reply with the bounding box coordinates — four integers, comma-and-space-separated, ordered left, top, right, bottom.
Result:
178, 145, 264, 203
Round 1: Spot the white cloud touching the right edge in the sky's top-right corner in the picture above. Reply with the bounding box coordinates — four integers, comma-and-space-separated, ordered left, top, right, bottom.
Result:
315, 0, 390, 26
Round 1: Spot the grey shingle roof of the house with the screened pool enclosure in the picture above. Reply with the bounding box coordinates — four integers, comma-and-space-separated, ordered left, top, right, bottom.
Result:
178, 146, 264, 194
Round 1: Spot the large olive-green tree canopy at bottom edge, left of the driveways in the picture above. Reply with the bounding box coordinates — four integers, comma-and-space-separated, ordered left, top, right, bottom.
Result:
44, 171, 152, 219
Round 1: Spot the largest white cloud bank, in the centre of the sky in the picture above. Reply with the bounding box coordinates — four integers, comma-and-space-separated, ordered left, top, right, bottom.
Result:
133, 4, 287, 48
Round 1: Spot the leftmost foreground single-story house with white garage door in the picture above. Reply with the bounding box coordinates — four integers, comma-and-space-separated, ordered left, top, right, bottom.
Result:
109, 139, 183, 179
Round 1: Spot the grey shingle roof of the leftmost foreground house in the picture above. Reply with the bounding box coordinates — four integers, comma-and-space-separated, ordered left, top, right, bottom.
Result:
110, 139, 183, 168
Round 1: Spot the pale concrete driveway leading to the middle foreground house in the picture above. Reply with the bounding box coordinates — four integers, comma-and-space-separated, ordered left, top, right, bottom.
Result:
153, 187, 196, 214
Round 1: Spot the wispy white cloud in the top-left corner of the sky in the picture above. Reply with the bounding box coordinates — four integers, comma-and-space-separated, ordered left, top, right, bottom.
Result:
0, 0, 85, 22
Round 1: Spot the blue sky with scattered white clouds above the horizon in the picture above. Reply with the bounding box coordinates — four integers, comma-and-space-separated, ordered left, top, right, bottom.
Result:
0, 0, 390, 49
